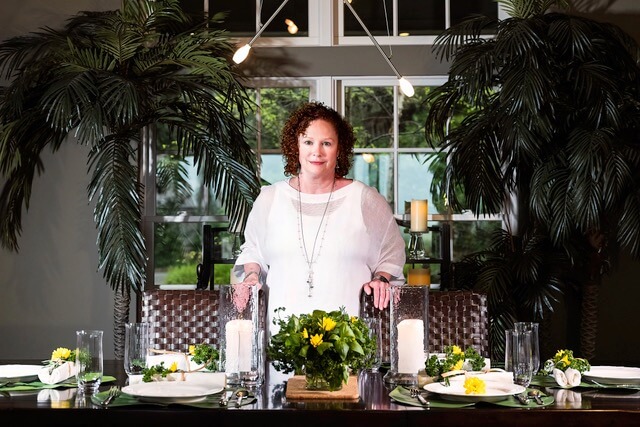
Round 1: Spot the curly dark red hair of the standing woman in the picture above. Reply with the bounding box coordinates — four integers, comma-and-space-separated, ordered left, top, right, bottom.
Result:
280, 101, 356, 177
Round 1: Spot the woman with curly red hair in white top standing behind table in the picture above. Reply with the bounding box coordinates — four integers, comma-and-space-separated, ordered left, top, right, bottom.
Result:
234, 102, 405, 330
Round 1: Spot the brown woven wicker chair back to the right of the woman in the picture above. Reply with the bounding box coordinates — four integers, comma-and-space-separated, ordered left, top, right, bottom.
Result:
360, 290, 490, 363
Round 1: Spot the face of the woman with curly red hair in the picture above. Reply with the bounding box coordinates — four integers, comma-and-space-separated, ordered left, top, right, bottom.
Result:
298, 119, 338, 179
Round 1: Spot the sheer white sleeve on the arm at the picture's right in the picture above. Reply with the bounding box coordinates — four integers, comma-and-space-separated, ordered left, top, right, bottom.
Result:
362, 186, 406, 284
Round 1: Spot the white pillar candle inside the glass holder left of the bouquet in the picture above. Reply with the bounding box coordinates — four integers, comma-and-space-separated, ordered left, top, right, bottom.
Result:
225, 319, 253, 372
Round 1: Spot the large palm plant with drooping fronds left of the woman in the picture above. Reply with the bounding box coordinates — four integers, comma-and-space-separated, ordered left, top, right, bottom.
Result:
0, 0, 260, 357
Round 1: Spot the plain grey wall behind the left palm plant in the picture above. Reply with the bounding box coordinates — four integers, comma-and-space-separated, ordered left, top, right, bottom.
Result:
0, 0, 120, 360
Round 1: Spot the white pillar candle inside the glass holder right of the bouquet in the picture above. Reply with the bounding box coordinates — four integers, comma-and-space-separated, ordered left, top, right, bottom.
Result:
398, 319, 425, 375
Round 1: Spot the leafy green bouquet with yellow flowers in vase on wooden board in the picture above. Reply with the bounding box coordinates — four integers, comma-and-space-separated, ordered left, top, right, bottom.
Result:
267, 307, 376, 391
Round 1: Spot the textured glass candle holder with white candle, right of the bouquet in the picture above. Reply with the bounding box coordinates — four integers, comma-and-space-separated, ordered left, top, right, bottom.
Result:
384, 285, 429, 385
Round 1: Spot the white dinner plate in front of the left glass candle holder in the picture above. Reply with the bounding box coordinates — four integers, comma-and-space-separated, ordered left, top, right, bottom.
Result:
122, 381, 224, 403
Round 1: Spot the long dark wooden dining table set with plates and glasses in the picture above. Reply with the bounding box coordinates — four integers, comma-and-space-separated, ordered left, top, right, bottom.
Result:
0, 360, 640, 427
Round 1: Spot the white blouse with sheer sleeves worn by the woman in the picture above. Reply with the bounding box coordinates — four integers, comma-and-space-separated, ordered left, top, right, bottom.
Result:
234, 180, 405, 329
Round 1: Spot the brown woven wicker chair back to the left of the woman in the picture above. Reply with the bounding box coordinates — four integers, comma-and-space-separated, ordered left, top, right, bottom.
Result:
141, 287, 267, 353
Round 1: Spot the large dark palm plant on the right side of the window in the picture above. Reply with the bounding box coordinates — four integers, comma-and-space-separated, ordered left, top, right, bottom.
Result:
425, 0, 640, 358
